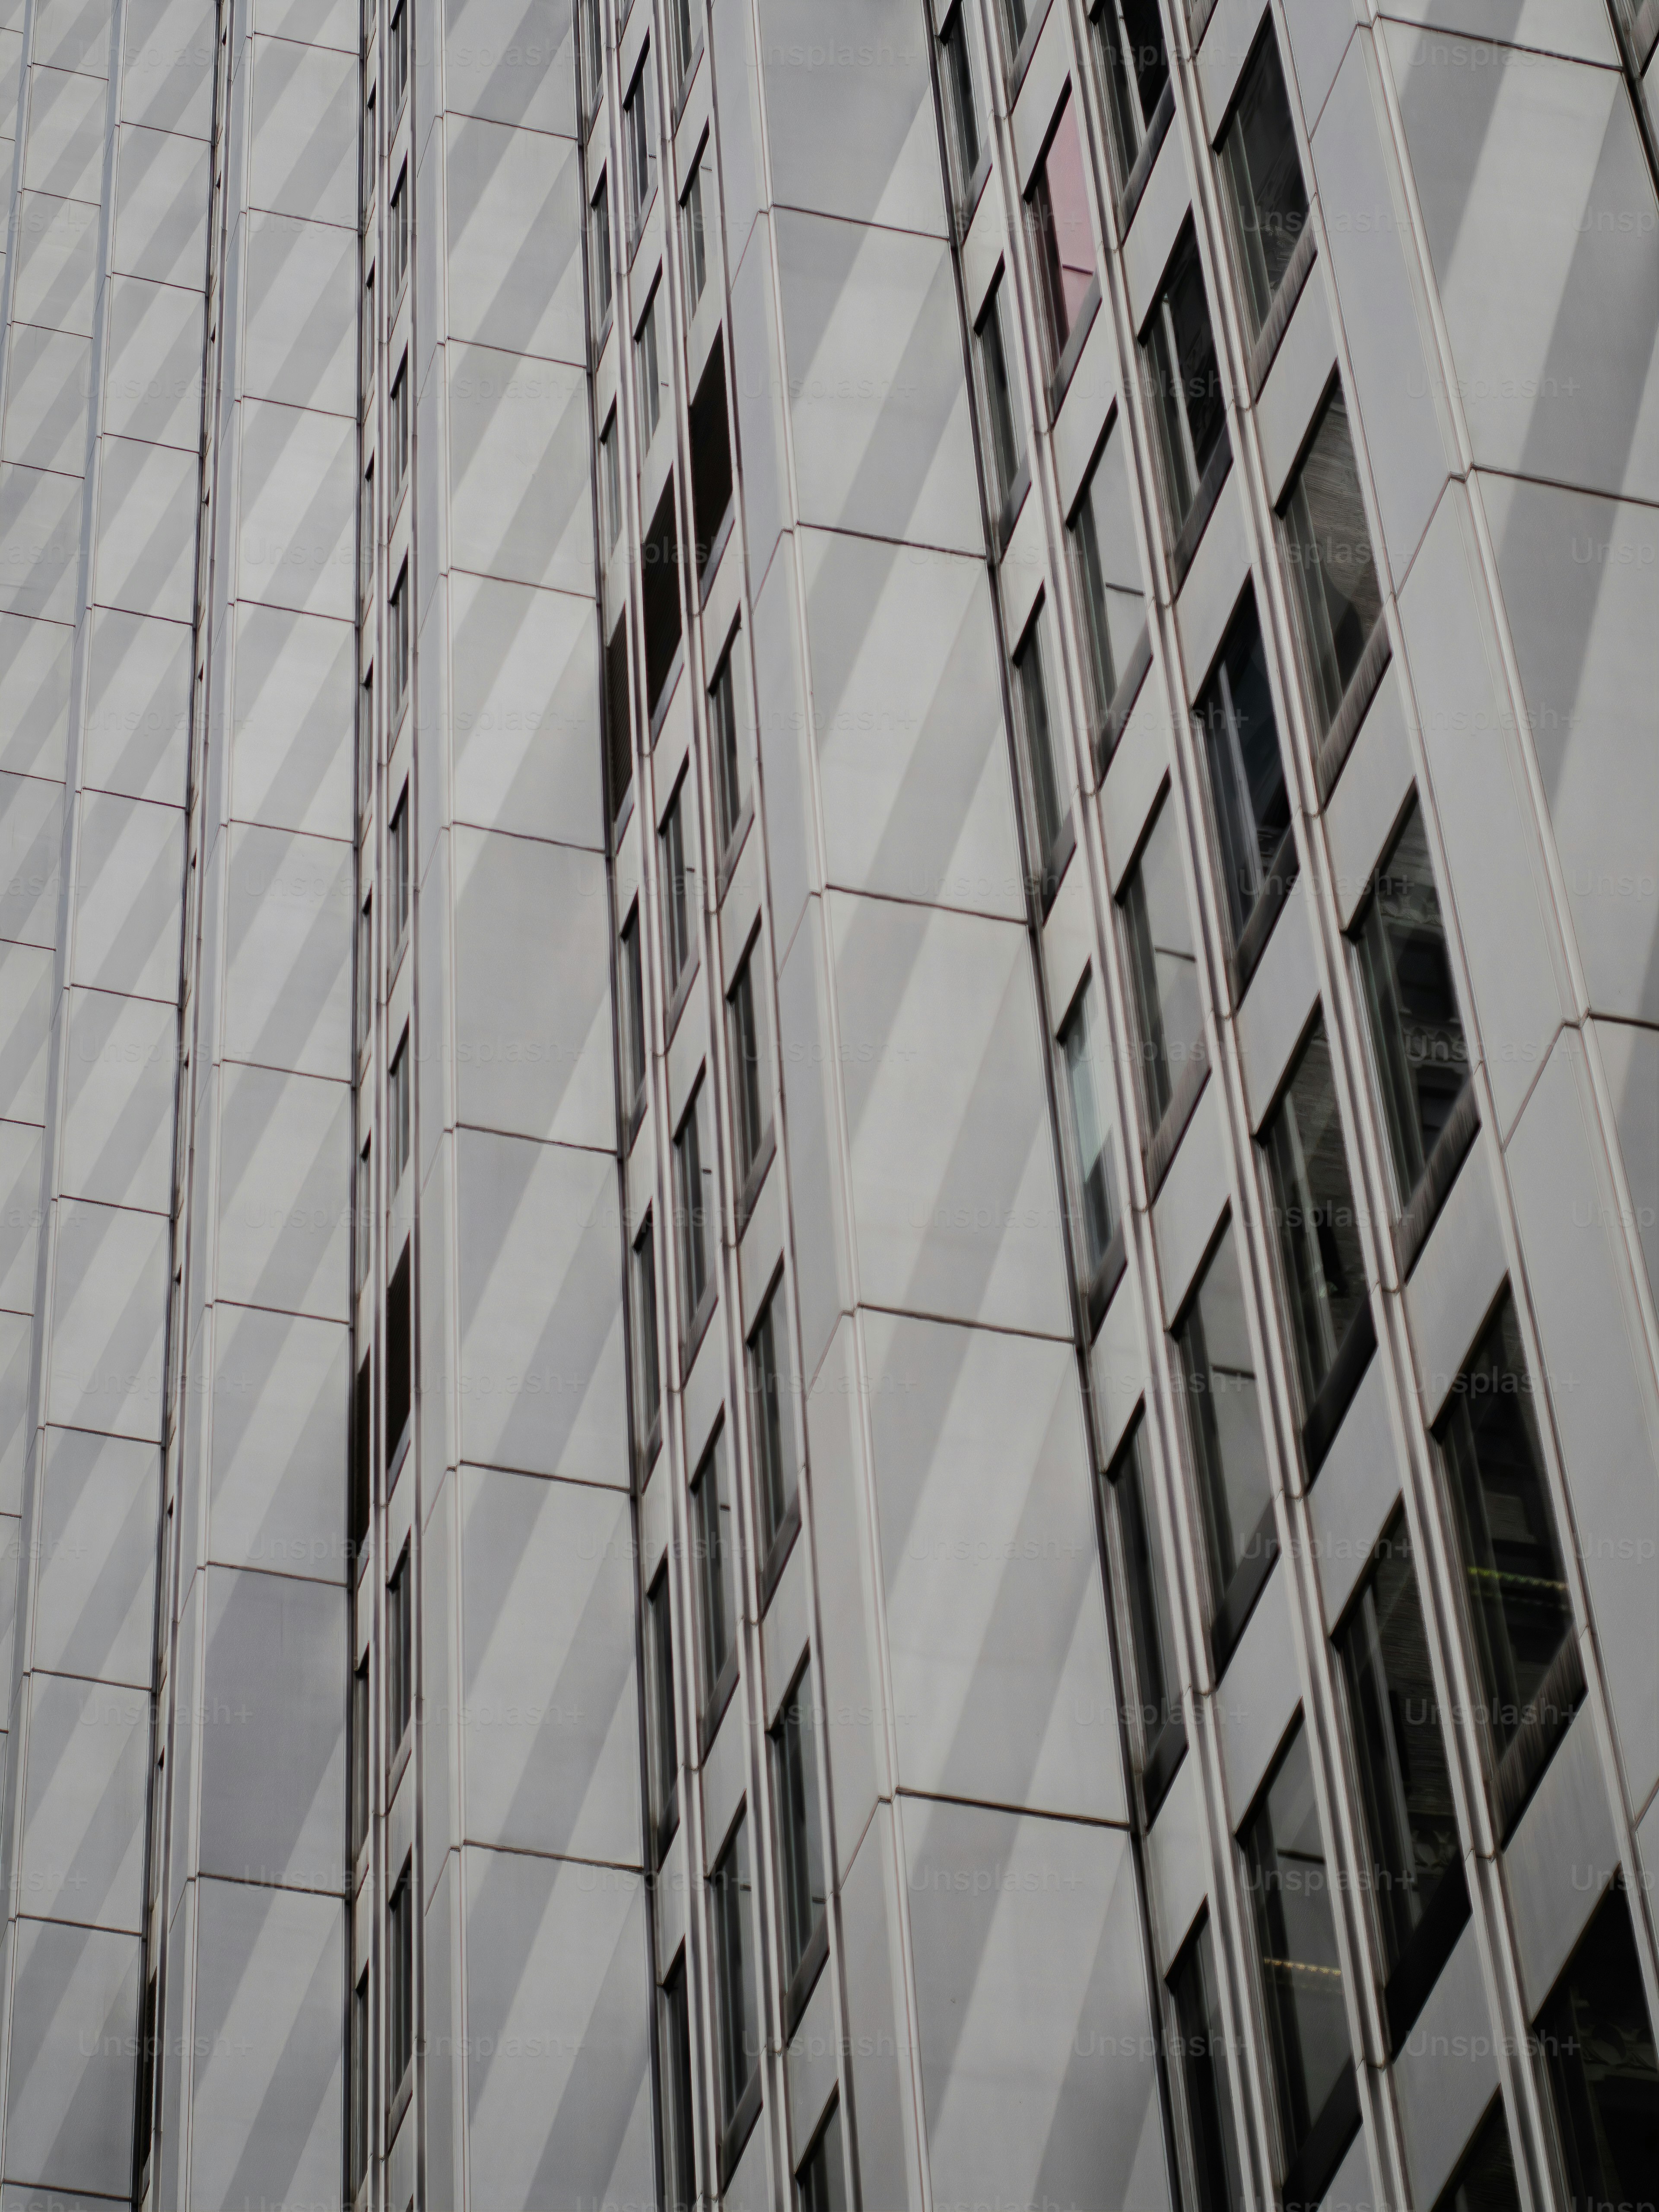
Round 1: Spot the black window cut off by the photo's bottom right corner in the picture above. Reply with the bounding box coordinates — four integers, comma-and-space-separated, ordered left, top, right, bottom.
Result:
1537, 1889, 1659, 2206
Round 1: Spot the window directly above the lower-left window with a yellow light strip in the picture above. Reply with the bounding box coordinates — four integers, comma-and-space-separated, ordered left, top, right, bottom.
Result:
1175, 1223, 1278, 1672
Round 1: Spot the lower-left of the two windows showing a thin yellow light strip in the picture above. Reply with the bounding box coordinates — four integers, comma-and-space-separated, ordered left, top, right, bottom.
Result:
1239, 1721, 1358, 2199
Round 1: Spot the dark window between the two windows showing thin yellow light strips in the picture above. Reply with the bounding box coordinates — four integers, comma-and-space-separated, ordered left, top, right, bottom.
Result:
1341, 1515, 1460, 1969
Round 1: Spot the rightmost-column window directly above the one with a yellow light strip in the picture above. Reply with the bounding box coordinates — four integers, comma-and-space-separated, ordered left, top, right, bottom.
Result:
1354, 801, 1469, 1205
